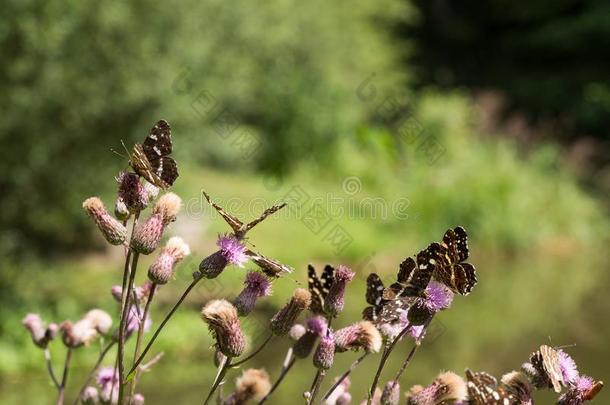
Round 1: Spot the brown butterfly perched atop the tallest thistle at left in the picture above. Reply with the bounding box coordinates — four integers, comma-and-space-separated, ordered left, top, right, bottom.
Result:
129, 120, 178, 189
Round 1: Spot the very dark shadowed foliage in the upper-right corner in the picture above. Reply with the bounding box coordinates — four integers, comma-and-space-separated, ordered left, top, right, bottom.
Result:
401, 0, 610, 145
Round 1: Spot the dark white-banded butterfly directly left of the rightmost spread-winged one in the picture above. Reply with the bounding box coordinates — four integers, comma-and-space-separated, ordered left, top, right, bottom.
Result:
383, 249, 435, 300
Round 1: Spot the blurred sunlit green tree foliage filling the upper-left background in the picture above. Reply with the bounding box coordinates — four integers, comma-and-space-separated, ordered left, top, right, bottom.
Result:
0, 0, 405, 255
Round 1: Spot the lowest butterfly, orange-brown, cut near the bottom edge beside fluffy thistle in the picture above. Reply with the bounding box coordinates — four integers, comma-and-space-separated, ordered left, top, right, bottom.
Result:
466, 369, 522, 405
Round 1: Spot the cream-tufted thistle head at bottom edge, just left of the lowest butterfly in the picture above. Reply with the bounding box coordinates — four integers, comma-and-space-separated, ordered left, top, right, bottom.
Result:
407, 371, 468, 405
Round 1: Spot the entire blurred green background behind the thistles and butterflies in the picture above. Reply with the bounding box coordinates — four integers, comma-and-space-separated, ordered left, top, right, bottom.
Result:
0, 0, 610, 404
